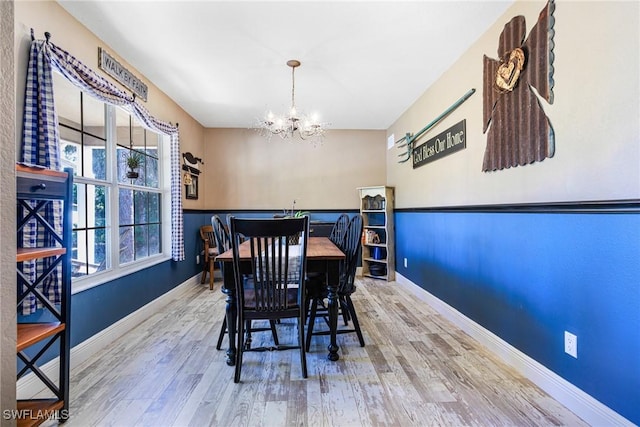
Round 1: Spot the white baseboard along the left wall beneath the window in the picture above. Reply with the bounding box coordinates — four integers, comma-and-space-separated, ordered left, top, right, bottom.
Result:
16, 273, 200, 399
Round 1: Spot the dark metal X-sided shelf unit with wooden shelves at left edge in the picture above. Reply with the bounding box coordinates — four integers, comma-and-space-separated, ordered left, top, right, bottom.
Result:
16, 165, 73, 426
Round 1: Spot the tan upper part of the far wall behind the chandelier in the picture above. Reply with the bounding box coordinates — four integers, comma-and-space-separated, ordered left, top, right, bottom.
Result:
201, 129, 386, 210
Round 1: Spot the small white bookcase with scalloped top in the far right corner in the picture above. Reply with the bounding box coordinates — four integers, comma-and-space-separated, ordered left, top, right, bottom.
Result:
358, 186, 395, 281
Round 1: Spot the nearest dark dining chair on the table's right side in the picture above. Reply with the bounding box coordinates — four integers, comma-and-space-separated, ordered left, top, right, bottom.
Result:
305, 214, 364, 351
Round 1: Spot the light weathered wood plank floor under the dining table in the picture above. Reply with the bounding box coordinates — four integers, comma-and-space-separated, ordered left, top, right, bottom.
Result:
53, 279, 586, 427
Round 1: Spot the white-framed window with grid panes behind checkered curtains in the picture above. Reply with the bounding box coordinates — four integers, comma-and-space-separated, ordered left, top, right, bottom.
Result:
54, 74, 170, 288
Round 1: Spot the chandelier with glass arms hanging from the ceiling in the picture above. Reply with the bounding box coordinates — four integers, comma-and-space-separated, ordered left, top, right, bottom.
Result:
259, 59, 327, 141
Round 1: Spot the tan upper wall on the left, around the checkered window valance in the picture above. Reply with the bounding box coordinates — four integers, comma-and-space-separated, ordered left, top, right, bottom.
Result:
15, 1, 204, 209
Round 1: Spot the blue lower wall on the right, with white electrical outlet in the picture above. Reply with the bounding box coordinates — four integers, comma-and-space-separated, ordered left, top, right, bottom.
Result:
394, 209, 640, 424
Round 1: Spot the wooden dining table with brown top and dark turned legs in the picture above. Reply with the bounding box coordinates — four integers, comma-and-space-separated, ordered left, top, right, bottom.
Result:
215, 237, 345, 366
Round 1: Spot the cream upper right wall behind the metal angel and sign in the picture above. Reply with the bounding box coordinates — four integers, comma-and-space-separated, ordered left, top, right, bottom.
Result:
387, 0, 640, 208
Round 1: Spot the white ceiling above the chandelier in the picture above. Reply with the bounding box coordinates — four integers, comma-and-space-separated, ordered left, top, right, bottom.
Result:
53, 0, 513, 129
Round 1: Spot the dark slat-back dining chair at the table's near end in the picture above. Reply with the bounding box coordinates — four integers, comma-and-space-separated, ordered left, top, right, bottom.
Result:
231, 216, 309, 383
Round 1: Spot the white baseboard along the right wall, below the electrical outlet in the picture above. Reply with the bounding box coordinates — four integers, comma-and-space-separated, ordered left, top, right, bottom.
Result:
396, 272, 634, 426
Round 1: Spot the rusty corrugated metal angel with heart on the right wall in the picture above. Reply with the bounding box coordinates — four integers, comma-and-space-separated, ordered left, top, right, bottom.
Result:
482, 0, 555, 172
